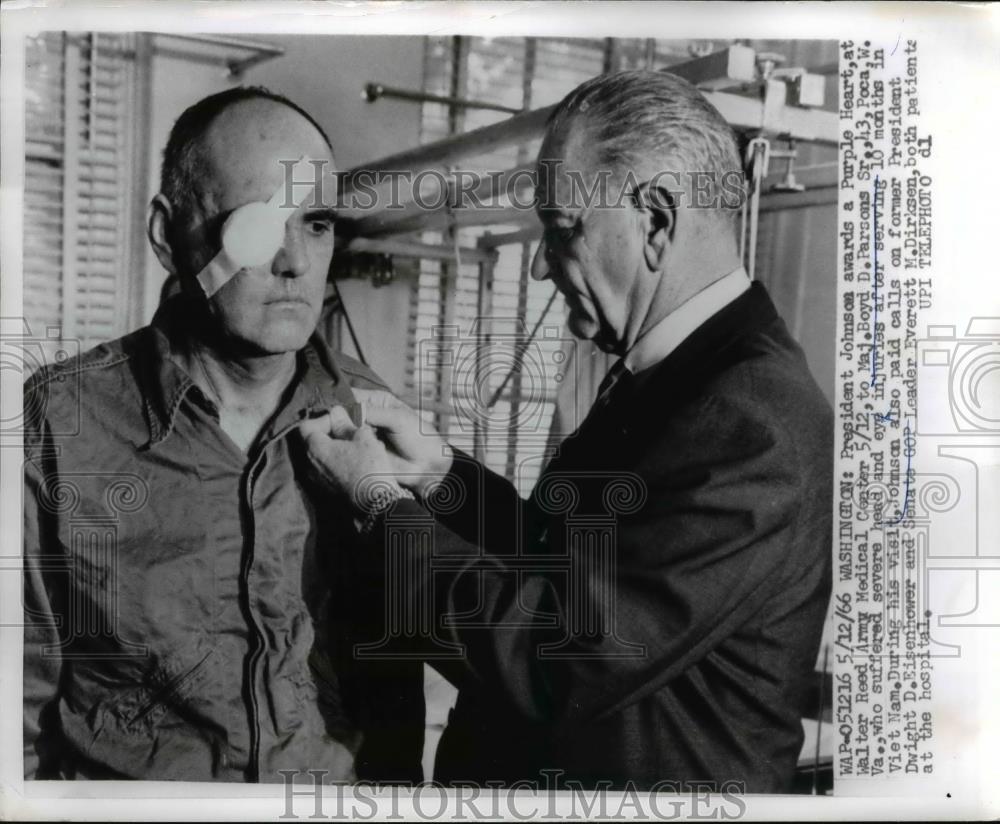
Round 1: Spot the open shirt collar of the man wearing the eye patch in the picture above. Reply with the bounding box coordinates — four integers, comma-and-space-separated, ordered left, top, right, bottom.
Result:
136, 295, 353, 447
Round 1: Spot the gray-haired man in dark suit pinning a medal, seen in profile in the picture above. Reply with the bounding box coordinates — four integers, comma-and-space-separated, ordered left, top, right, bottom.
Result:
305, 72, 833, 792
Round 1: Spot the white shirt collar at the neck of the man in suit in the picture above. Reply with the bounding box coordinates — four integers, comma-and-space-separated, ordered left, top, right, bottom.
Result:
624, 266, 750, 375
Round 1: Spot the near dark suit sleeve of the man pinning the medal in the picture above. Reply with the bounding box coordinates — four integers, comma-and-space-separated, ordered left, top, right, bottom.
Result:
358, 399, 801, 722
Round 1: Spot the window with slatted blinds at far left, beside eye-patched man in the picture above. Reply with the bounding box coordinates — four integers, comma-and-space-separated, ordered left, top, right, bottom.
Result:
24, 32, 145, 350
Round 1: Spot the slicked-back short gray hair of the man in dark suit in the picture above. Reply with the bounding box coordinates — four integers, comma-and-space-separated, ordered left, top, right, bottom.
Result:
546, 70, 744, 224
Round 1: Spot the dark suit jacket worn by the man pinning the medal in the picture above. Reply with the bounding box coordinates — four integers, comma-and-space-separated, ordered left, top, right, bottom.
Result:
364, 284, 833, 792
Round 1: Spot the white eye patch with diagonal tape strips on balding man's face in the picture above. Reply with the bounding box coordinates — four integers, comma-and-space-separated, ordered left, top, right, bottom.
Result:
198, 157, 328, 297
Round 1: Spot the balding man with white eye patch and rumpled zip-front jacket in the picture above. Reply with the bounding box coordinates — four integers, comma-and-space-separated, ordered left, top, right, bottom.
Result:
24, 88, 423, 783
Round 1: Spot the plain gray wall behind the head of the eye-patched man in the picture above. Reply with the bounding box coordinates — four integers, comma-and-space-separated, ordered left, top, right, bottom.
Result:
143, 35, 424, 391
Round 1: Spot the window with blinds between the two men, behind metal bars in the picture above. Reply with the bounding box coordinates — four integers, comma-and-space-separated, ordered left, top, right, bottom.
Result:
408, 38, 604, 494
